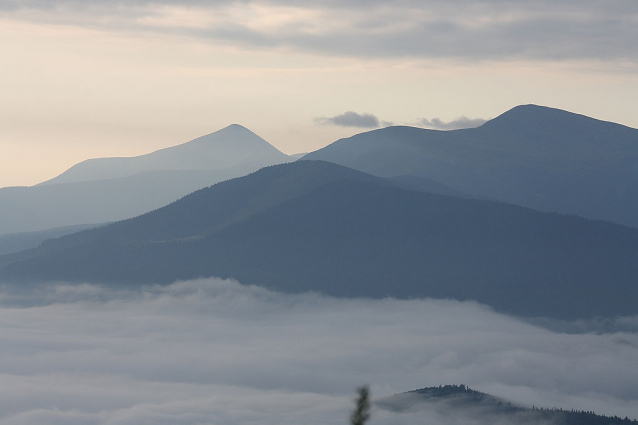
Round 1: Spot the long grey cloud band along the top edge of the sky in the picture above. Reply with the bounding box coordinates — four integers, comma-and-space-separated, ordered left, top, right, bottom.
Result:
0, 0, 638, 62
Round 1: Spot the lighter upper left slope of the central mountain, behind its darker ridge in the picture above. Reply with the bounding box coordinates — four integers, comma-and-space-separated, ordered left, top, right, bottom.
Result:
25, 161, 380, 246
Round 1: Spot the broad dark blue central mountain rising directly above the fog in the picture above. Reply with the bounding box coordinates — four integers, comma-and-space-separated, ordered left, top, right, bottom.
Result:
0, 161, 638, 319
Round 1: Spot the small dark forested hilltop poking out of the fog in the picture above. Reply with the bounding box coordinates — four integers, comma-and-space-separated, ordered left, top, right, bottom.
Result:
376, 385, 638, 425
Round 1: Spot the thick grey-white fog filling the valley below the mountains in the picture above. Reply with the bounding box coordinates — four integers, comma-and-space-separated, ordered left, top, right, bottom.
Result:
0, 279, 638, 425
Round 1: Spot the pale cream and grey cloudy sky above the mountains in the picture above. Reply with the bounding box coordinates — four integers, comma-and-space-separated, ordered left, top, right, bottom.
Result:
0, 0, 638, 187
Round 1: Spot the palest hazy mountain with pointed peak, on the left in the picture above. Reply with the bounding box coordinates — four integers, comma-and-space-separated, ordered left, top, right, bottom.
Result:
0, 125, 291, 235
